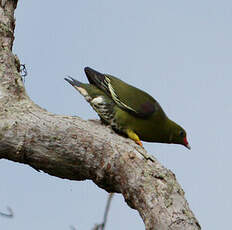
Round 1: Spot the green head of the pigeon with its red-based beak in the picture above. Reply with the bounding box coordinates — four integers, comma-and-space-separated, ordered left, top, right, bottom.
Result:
170, 124, 191, 149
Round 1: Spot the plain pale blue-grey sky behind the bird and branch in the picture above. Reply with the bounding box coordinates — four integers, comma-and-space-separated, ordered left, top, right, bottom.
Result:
0, 0, 232, 230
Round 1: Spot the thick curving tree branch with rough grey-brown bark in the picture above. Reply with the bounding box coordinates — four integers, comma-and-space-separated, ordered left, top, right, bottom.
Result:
0, 0, 200, 230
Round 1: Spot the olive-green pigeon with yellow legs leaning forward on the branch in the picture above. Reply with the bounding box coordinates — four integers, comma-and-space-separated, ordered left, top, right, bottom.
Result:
64, 67, 191, 149
